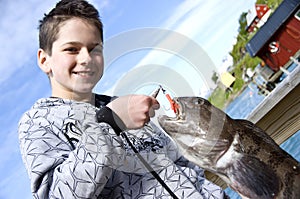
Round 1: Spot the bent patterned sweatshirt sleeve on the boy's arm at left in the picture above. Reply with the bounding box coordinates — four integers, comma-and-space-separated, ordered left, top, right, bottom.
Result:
19, 109, 121, 198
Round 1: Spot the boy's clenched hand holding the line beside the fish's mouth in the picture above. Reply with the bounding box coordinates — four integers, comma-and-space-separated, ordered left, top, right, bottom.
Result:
107, 95, 159, 129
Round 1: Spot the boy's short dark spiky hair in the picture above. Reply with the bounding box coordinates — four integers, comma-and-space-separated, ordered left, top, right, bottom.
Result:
39, 0, 103, 55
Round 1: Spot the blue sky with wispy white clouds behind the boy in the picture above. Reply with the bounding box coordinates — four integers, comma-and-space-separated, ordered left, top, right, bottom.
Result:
0, 0, 255, 199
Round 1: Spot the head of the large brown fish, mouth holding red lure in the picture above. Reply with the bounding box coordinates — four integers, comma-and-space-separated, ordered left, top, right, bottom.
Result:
158, 97, 229, 168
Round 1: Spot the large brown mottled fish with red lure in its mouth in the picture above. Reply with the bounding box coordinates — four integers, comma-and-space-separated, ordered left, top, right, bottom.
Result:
158, 96, 300, 199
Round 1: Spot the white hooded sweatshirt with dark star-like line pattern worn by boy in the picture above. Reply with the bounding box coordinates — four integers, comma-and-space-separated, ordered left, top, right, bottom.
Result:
19, 95, 224, 198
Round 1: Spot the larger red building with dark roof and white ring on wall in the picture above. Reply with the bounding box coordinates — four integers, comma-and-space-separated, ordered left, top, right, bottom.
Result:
246, 0, 300, 72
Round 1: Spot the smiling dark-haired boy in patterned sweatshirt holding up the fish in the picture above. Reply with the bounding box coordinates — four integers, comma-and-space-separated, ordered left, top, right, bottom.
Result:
19, 0, 223, 198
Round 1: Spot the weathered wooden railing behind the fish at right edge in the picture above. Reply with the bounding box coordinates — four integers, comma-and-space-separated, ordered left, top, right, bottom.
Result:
247, 65, 300, 144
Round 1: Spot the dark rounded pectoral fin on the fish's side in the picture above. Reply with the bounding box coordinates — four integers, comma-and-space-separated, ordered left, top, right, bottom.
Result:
228, 155, 281, 199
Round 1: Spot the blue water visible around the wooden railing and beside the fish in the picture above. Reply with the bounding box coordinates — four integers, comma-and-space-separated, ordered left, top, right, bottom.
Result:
225, 84, 300, 199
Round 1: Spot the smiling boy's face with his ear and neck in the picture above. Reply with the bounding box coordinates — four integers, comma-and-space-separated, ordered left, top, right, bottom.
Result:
38, 18, 103, 98
